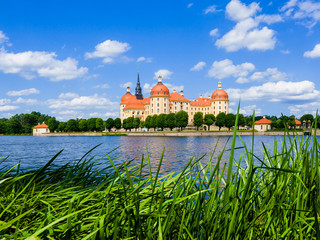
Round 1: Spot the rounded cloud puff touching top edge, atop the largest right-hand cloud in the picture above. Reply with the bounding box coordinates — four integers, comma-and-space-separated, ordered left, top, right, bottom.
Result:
226, 0, 261, 21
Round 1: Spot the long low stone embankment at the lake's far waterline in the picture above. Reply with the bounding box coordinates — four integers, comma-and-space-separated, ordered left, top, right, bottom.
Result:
27, 131, 320, 137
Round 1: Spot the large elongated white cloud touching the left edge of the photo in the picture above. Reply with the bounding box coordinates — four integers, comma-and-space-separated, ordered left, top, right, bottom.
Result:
0, 49, 88, 81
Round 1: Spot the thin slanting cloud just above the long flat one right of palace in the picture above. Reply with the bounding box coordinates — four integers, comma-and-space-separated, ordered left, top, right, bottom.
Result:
236, 68, 288, 83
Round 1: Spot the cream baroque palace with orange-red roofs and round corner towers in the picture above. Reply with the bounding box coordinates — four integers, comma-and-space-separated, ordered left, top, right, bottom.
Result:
120, 74, 229, 123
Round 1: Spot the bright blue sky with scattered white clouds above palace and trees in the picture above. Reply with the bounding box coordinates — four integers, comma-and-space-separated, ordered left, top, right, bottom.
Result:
0, 0, 320, 121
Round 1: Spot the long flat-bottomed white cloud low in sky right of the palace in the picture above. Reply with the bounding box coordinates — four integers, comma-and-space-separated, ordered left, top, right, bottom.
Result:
226, 80, 320, 102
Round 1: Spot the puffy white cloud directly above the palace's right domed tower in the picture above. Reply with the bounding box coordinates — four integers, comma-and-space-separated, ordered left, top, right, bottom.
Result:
208, 59, 255, 79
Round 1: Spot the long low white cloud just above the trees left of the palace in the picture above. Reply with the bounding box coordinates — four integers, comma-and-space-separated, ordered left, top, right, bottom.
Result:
47, 94, 119, 111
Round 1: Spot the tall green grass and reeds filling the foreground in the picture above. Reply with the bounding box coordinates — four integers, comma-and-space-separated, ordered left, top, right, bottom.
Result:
0, 130, 320, 239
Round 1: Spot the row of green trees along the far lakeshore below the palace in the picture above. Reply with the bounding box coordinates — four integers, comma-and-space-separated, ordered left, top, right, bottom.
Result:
0, 111, 320, 134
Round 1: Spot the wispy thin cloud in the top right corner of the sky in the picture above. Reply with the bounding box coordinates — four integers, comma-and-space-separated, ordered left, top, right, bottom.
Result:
280, 0, 320, 28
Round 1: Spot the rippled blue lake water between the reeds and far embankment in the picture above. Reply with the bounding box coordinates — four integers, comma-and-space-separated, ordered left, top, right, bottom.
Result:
0, 136, 298, 173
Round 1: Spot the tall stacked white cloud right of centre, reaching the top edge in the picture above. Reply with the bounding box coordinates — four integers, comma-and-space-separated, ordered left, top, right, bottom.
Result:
215, 0, 282, 52
